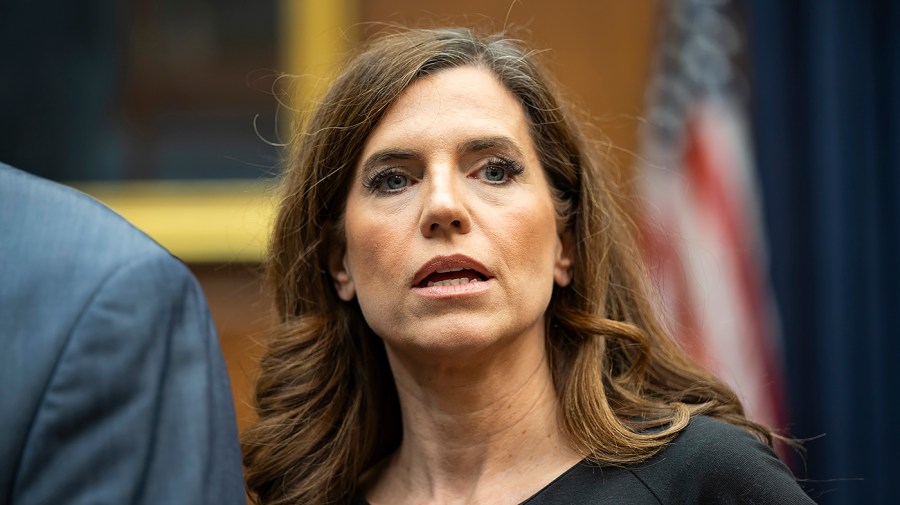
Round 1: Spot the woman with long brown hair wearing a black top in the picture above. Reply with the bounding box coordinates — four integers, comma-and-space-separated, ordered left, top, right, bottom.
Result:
244, 29, 808, 505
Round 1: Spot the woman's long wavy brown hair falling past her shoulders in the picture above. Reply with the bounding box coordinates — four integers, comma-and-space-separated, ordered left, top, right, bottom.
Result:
243, 28, 773, 504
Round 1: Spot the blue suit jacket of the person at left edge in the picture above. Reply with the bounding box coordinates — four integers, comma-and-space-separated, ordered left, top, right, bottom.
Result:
0, 164, 246, 505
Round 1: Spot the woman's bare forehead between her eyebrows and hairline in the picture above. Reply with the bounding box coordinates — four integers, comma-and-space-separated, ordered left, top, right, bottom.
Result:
362, 66, 534, 159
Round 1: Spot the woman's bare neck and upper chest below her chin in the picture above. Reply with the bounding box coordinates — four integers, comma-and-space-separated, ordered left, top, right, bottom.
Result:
369, 334, 581, 503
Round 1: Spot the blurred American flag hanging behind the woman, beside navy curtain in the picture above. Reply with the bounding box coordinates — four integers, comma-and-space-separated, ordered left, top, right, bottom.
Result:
638, 0, 786, 434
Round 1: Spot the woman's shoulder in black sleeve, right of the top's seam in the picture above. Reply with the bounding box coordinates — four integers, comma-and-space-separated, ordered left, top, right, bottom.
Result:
631, 416, 812, 503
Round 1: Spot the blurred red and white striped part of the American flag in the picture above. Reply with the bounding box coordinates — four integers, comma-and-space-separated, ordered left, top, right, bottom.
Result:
642, 99, 785, 427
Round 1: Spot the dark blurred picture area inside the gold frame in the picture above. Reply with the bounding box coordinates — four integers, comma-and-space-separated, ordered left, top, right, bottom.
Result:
0, 0, 278, 181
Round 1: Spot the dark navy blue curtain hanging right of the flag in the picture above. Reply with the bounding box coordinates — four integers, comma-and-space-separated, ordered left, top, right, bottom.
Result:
749, 0, 900, 504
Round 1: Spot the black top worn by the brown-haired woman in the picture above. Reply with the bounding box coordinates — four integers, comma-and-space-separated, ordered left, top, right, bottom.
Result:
353, 416, 813, 505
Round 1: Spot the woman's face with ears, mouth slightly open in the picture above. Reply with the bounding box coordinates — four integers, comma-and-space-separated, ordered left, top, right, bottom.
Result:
331, 67, 571, 356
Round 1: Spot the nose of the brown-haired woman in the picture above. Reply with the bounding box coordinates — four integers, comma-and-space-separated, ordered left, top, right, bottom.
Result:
419, 165, 472, 238
